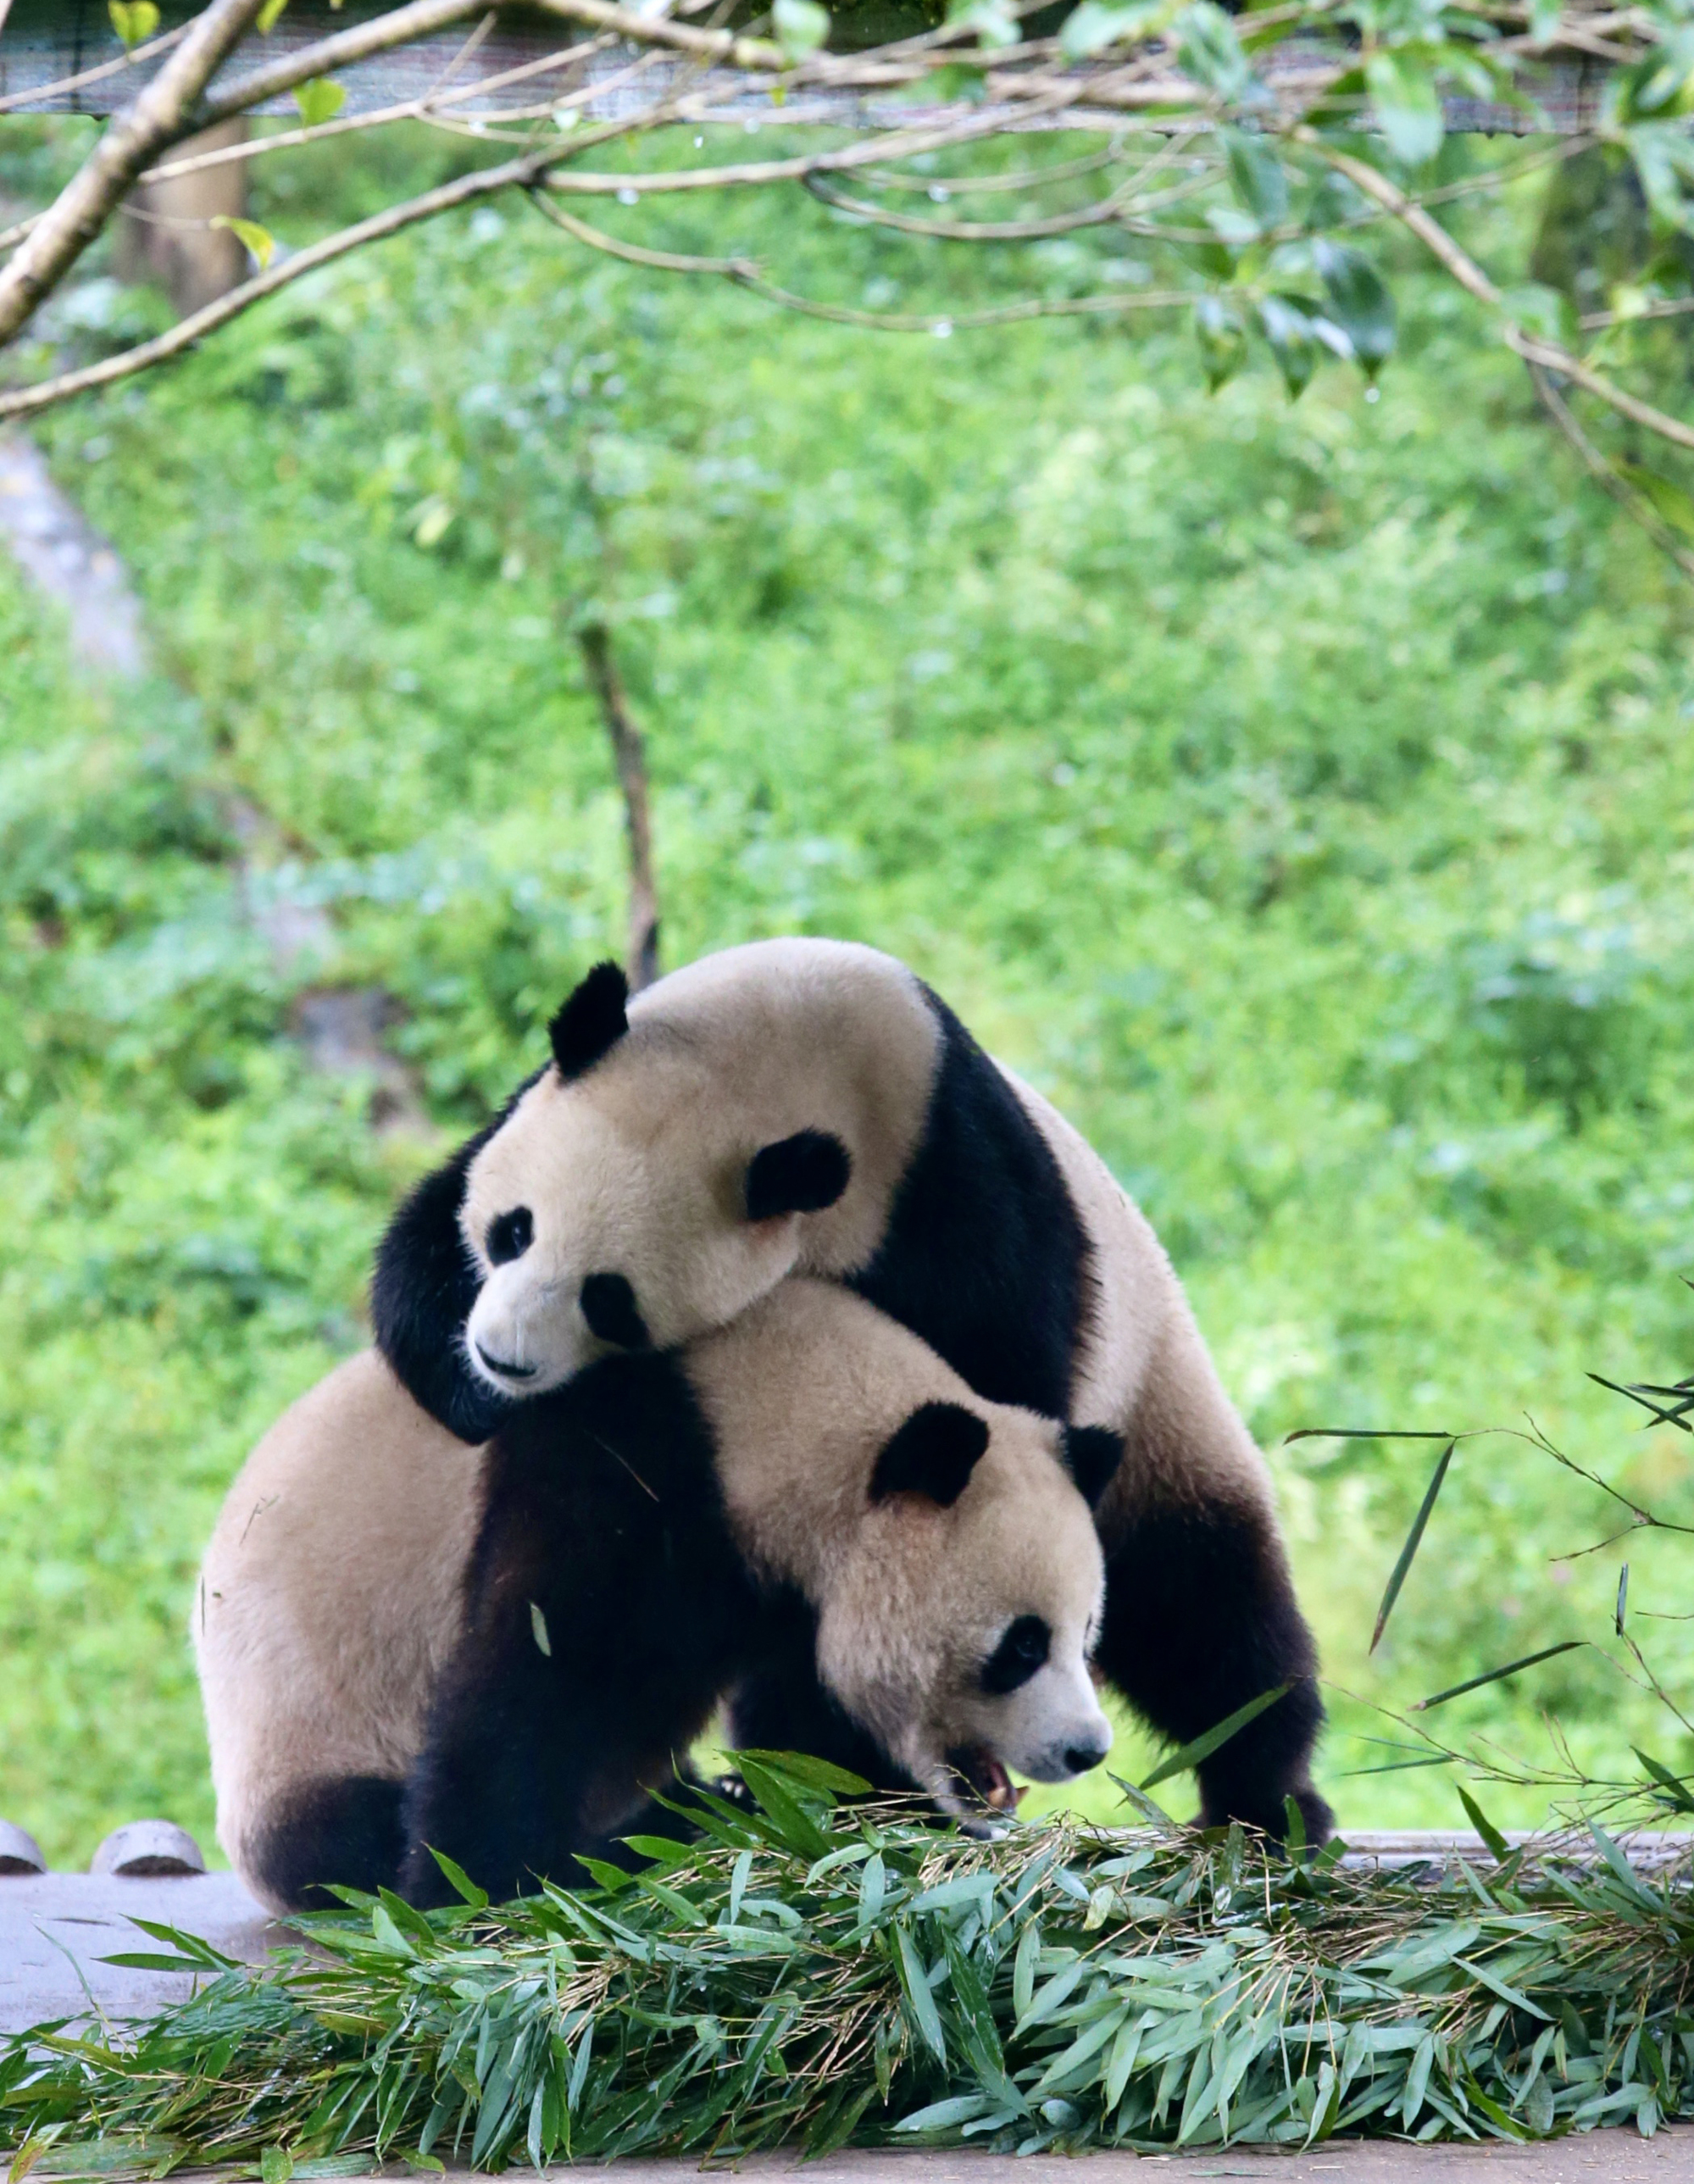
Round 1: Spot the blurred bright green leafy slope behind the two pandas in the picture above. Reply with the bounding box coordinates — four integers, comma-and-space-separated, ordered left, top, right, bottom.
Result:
0, 125, 1694, 1861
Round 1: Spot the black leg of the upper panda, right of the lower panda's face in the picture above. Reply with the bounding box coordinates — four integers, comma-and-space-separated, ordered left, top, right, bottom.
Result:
1096, 1498, 1334, 1843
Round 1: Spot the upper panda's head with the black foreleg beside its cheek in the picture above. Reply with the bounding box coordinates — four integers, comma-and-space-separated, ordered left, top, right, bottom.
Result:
374, 963, 853, 1439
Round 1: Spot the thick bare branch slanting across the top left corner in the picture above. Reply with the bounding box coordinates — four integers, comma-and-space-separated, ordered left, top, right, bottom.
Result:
0, 0, 264, 343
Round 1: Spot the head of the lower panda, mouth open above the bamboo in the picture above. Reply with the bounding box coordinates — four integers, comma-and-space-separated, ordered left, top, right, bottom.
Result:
816, 1402, 1122, 1828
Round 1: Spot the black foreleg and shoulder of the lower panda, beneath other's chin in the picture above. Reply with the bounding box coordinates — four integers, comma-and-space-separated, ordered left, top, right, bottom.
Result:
404, 1356, 755, 1903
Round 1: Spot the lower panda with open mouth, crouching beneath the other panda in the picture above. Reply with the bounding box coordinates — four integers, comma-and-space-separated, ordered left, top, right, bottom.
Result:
194, 1280, 1120, 1909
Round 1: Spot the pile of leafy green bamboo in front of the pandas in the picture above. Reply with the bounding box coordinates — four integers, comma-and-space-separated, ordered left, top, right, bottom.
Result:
0, 1758, 1694, 2184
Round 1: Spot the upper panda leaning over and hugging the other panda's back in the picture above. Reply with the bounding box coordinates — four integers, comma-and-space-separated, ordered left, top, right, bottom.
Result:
374, 939, 1331, 1841
